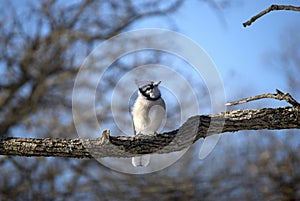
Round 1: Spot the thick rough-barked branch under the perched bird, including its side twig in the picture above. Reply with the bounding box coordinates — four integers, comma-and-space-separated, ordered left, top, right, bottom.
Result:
0, 90, 300, 158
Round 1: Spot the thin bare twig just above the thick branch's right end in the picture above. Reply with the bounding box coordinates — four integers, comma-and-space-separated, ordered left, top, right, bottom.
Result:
225, 89, 300, 107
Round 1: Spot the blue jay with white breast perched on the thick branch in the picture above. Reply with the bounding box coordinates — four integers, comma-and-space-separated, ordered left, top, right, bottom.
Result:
131, 81, 166, 167
